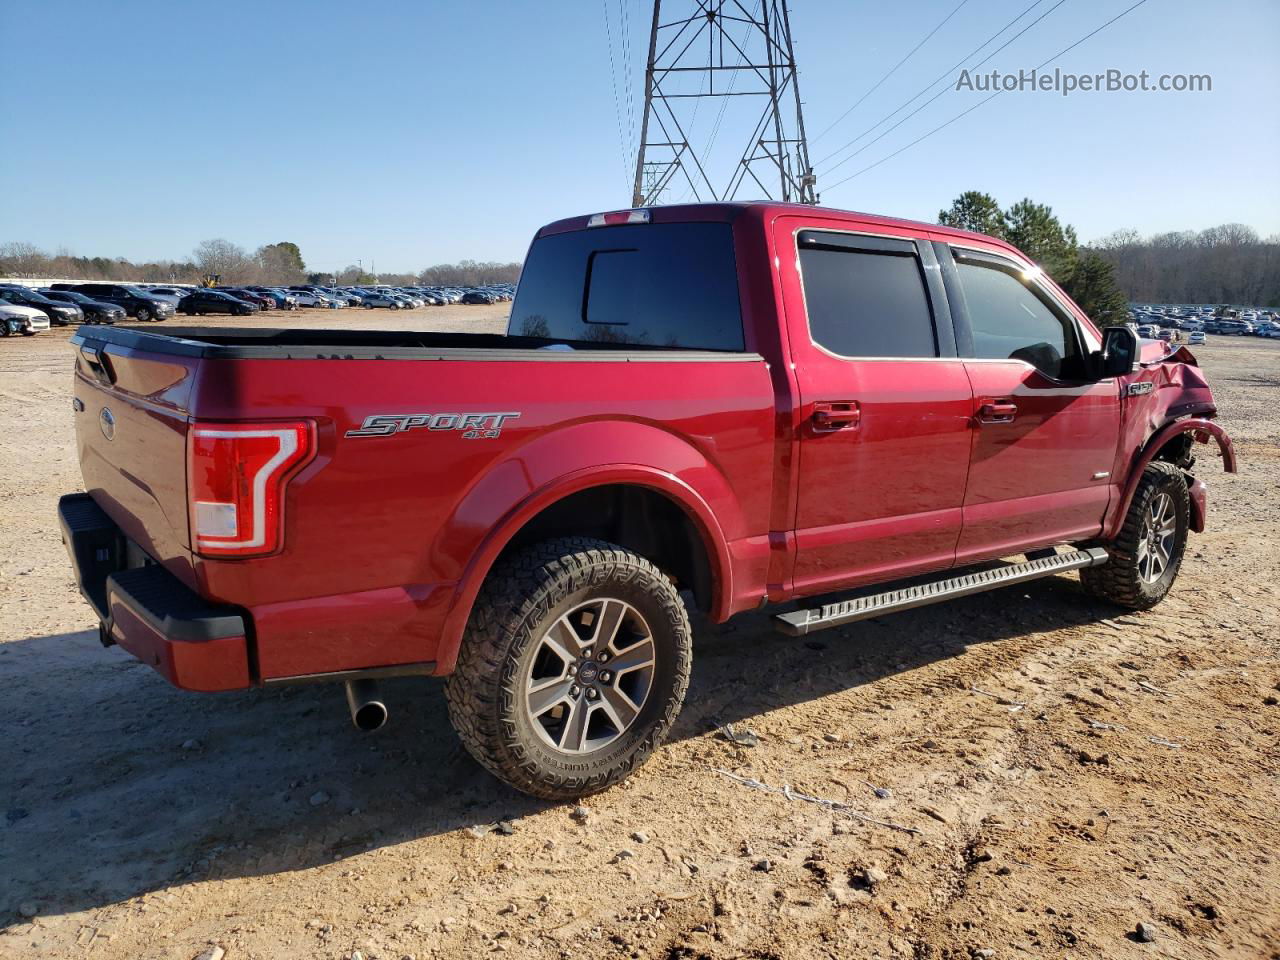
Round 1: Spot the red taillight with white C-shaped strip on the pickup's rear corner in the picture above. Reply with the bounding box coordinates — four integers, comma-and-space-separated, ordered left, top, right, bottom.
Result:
187, 421, 315, 557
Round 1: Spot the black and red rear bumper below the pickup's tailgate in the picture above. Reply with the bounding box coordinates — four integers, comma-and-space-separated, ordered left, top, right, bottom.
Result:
58, 494, 252, 691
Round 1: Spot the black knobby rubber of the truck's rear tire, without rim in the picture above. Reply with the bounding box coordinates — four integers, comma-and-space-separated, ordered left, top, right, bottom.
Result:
444, 538, 692, 800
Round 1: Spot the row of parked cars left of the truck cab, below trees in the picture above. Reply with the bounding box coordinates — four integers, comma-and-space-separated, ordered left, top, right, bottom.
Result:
0, 283, 515, 337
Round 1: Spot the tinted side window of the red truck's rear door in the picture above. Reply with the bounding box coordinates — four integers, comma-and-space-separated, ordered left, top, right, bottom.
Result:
799, 230, 938, 357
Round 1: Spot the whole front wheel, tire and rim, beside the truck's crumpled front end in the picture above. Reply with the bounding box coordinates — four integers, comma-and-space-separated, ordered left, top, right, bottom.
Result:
1080, 461, 1190, 611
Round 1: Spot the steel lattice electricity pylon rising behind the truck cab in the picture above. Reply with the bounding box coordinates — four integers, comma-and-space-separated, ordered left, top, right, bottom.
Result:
631, 0, 818, 206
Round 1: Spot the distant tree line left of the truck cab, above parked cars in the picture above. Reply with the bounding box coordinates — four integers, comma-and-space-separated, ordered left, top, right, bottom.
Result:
0, 238, 521, 287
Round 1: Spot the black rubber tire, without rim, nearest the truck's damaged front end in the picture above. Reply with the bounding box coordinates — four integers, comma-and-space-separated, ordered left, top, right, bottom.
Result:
1080, 461, 1190, 611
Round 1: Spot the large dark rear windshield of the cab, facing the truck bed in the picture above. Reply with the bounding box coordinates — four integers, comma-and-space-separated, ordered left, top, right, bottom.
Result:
508, 223, 742, 349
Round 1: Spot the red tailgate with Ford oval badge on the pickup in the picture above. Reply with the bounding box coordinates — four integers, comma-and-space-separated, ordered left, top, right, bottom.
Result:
72, 329, 200, 586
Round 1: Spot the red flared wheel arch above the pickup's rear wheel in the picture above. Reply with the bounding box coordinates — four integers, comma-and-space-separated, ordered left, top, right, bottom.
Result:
433, 421, 746, 673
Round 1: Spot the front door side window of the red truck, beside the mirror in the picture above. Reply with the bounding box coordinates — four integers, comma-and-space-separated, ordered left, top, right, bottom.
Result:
956, 262, 1076, 378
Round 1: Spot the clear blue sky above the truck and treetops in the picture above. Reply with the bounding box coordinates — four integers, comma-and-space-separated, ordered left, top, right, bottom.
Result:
0, 0, 1280, 270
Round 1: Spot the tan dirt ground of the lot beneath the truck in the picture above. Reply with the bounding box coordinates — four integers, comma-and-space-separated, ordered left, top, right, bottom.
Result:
0, 313, 1280, 960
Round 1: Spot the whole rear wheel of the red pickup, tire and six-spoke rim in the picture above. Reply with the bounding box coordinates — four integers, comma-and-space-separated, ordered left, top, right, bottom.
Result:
445, 538, 692, 800
